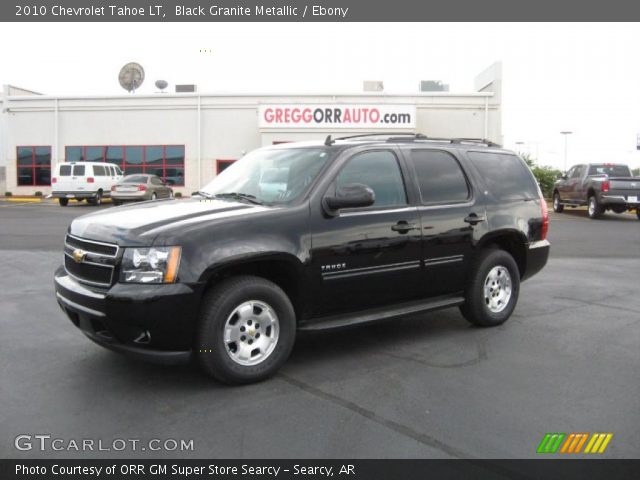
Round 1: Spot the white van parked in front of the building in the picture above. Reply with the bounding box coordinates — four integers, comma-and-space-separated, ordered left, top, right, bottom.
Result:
51, 162, 122, 207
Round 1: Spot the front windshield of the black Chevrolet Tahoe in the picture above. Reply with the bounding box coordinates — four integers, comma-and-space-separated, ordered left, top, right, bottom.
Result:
202, 148, 329, 204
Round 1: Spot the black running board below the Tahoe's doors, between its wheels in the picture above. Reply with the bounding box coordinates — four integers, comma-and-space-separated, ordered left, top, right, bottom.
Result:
298, 296, 464, 332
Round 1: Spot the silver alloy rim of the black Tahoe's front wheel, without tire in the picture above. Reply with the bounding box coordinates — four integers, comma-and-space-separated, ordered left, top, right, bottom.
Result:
224, 300, 280, 366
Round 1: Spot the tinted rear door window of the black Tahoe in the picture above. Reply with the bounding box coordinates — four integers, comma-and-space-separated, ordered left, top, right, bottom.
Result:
410, 150, 469, 204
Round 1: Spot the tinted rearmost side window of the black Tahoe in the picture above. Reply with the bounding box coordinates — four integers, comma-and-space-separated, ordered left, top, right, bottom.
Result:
467, 152, 539, 201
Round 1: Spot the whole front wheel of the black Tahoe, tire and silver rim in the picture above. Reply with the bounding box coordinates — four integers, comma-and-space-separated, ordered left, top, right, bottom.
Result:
194, 276, 296, 384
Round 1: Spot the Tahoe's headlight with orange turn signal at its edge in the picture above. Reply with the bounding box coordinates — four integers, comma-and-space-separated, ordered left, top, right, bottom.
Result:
120, 247, 180, 283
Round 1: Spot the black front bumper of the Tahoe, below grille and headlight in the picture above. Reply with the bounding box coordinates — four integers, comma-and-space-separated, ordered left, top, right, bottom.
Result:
54, 266, 200, 364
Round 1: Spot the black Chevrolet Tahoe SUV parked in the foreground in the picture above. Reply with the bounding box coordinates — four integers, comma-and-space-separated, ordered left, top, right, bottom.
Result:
55, 135, 549, 383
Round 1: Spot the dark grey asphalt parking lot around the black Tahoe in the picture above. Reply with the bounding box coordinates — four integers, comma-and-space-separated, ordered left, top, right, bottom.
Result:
0, 203, 640, 458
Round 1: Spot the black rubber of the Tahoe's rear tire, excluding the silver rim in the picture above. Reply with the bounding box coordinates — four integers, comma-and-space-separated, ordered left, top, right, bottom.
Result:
465, 249, 520, 327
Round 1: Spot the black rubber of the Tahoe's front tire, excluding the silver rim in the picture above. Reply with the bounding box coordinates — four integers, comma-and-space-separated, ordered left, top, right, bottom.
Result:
195, 276, 296, 384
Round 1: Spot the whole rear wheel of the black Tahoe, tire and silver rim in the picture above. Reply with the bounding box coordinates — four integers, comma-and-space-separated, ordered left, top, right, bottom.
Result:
460, 248, 520, 327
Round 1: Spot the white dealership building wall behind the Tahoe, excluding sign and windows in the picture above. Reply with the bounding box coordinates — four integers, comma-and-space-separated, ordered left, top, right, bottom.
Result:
0, 88, 502, 195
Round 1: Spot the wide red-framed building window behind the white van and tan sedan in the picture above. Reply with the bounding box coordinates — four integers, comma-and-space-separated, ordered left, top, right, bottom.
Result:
66, 145, 185, 187
